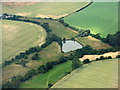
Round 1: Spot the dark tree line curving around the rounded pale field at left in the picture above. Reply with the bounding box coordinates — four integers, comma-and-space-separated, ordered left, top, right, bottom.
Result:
2, 14, 62, 68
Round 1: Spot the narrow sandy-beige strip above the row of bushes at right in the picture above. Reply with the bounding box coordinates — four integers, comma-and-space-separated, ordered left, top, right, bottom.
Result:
80, 51, 120, 61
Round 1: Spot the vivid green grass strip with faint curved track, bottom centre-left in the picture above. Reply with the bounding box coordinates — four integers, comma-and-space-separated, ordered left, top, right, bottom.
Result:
21, 61, 71, 88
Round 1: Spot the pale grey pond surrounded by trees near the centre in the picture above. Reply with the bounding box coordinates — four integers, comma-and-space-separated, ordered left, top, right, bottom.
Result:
62, 40, 83, 52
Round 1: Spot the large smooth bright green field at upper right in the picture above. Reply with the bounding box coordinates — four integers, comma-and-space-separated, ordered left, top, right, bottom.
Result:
64, 2, 118, 37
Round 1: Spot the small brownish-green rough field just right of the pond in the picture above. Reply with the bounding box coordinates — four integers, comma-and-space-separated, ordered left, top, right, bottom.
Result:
76, 36, 112, 49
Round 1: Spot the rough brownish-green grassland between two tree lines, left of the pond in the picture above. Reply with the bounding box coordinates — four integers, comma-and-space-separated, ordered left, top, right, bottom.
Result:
2, 42, 63, 83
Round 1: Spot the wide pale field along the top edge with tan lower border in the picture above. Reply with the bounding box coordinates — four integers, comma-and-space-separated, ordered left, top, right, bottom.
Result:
2, 2, 89, 18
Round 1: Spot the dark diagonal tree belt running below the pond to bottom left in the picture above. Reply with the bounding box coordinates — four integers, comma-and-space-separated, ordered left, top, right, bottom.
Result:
3, 46, 120, 88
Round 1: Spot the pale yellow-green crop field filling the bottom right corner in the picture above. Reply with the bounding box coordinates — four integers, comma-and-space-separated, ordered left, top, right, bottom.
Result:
52, 59, 118, 88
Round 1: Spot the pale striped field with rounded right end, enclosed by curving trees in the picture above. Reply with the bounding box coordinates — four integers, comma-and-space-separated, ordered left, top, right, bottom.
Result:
2, 20, 46, 60
